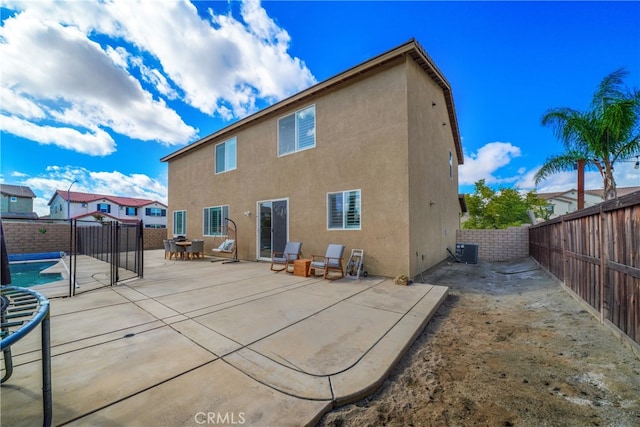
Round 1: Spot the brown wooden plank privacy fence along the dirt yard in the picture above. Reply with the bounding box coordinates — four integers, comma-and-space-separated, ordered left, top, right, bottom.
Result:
529, 192, 640, 344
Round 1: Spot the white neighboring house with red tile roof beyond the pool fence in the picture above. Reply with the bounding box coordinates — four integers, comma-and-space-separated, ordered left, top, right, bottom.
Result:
49, 190, 167, 228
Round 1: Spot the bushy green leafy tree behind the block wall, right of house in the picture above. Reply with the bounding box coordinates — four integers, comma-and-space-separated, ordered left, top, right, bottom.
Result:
462, 179, 549, 229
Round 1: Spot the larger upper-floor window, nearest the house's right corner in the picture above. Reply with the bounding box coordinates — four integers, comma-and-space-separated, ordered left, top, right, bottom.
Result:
278, 105, 316, 156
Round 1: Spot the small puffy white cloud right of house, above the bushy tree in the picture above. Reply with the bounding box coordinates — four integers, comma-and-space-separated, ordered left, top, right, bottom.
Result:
458, 142, 521, 185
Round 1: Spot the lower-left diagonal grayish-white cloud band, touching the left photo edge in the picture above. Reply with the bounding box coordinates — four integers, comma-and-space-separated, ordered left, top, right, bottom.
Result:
0, 7, 195, 155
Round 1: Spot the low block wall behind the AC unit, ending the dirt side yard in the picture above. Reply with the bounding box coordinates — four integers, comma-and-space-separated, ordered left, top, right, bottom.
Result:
456, 225, 529, 261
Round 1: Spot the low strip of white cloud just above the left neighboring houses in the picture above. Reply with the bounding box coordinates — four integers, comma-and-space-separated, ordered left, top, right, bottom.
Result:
19, 166, 167, 216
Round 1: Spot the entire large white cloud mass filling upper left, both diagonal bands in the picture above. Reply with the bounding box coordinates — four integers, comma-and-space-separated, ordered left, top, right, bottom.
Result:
0, 0, 315, 155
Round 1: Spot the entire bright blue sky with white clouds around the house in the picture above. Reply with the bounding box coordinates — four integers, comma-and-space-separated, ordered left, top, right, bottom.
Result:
0, 0, 640, 215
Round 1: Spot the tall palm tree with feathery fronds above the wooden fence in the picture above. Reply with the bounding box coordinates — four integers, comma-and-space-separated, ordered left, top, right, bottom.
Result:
535, 69, 640, 200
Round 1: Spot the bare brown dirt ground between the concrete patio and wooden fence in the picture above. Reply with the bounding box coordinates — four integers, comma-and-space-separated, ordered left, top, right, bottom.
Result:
319, 259, 640, 427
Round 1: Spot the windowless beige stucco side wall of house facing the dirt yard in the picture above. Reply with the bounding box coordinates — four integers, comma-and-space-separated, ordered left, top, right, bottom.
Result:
407, 60, 460, 276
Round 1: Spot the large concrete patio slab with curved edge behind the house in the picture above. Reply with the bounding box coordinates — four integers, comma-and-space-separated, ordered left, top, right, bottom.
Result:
1, 251, 448, 426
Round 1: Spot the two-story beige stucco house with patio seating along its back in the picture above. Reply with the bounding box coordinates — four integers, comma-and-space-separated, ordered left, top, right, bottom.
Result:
161, 40, 463, 277
